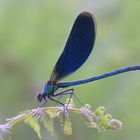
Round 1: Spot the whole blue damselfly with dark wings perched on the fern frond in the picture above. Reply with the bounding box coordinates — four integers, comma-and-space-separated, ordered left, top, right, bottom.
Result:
37, 12, 140, 105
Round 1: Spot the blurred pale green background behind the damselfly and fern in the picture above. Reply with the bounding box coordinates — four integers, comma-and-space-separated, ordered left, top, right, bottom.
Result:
0, 0, 140, 140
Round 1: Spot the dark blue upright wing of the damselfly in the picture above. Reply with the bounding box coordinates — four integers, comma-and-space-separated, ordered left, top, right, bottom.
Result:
50, 12, 96, 81
